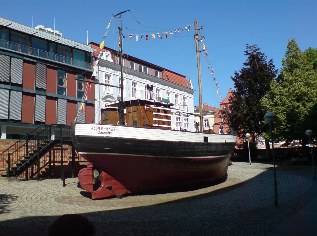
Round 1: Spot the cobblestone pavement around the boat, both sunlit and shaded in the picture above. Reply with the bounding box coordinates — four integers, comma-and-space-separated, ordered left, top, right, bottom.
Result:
0, 162, 317, 235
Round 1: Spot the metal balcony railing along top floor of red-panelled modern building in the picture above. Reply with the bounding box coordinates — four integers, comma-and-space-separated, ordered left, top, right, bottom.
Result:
0, 39, 92, 70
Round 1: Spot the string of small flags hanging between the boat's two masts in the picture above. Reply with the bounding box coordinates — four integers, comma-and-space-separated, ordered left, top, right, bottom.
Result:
124, 25, 192, 41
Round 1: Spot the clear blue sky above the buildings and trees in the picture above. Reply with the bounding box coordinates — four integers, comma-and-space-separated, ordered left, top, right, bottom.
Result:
0, 0, 317, 107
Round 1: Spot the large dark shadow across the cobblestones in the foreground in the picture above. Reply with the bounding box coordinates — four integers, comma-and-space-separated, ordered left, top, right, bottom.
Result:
0, 164, 316, 236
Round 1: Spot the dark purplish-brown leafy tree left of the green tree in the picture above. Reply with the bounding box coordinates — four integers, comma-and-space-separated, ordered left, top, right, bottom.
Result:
223, 45, 277, 135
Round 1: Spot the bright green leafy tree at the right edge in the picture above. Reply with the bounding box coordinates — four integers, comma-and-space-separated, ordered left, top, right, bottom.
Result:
262, 39, 317, 141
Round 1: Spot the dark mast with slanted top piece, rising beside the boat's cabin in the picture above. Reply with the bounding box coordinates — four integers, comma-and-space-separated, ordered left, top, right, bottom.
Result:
114, 10, 130, 125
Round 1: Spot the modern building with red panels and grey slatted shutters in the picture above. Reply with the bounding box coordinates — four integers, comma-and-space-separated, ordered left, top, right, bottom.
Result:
0, 18, 95, 139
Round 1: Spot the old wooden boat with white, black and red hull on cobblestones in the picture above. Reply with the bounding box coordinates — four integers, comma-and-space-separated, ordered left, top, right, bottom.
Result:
72, 18, 236, 199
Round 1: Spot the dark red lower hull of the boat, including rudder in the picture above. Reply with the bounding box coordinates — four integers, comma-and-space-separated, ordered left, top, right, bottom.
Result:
79, 153, 230, 199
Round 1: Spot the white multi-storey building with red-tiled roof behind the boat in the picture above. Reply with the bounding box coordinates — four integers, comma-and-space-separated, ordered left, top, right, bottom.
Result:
91, 43, 195, 131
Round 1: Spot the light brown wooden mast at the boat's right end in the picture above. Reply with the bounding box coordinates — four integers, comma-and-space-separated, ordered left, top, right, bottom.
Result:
194, 20, 204, 132
